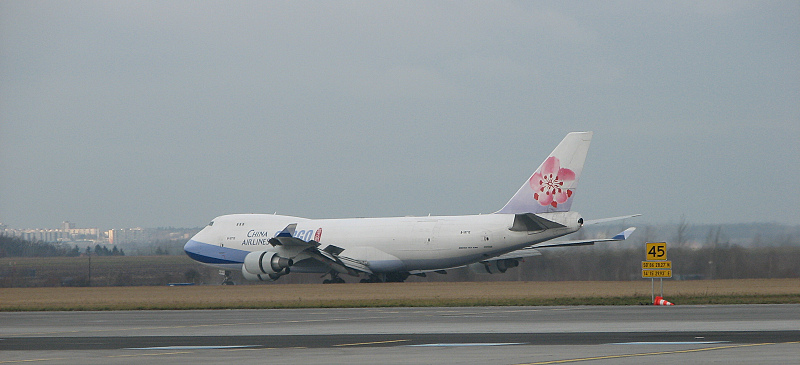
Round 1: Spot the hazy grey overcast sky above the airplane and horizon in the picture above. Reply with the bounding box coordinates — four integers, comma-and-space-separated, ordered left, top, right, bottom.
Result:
0, 1, 800, 228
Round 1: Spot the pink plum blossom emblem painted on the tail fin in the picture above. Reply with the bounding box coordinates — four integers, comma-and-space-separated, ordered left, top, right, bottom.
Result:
529, 156, 575, 208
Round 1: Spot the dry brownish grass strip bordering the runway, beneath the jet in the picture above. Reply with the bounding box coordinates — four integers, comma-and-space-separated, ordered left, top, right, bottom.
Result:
0, 279, 800, 311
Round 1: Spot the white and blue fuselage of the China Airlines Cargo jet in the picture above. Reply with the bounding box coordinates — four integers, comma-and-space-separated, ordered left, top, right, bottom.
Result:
187, 212, 581, 273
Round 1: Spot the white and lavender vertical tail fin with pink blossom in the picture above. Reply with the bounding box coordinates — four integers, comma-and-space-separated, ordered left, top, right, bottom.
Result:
496, 132, 592, 214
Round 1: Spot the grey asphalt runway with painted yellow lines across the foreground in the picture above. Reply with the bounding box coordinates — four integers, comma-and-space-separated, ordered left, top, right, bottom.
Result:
0, 305, 800, 364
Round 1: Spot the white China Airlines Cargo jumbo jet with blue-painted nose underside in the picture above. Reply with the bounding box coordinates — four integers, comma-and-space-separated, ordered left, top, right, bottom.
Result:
184, 132, 639, 284
